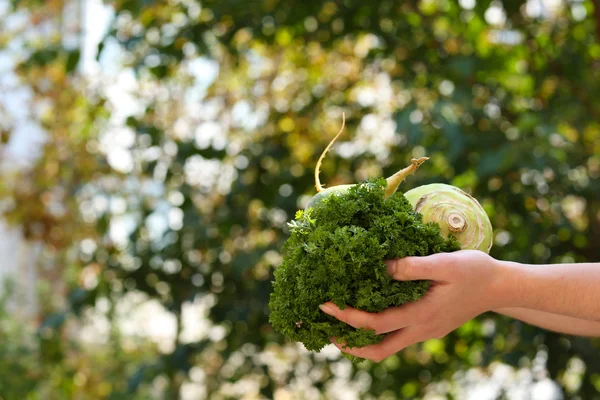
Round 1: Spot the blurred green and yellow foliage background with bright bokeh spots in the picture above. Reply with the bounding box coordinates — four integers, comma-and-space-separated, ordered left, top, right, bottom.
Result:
0, 0, 600, 400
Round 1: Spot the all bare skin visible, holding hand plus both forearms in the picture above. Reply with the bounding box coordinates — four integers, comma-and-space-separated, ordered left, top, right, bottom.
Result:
320, 250, 600, 362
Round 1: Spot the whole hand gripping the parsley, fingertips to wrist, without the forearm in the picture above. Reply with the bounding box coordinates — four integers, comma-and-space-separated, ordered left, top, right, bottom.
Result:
321, 250, 503, 362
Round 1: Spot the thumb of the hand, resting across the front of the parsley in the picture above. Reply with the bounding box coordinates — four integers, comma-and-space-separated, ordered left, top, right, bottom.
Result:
386, 254, 447, 281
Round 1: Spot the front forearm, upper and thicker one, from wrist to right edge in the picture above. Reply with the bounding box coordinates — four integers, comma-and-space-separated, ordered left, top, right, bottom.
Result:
496, 261, 600, 321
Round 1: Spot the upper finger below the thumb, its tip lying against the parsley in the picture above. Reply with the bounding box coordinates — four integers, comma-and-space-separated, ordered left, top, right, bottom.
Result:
319, 302, 419, 335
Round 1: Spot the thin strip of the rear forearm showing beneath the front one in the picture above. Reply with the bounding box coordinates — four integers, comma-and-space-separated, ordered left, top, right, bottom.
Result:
494, 308, 600, 337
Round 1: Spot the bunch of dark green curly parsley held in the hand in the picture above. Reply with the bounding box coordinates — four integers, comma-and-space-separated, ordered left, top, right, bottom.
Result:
269, 178, 460, 359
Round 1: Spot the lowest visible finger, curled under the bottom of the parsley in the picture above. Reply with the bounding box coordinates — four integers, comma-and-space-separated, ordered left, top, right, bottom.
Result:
333, 327, 423, 362
